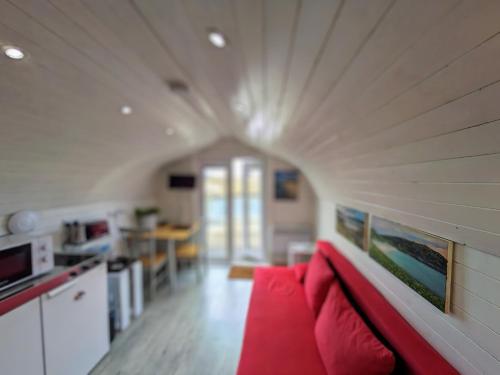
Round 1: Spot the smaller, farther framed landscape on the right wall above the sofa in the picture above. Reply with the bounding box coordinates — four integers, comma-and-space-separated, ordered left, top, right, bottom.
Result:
336, 205, 368, 250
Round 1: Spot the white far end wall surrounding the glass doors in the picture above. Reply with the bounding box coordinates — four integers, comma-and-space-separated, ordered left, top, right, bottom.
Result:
156, 138, 317, 261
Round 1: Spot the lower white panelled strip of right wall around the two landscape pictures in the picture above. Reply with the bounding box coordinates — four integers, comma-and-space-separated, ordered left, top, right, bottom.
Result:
319, 203, 500, 374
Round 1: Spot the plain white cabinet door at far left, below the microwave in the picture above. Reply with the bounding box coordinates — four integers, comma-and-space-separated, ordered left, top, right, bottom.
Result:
0, 298, 43, 375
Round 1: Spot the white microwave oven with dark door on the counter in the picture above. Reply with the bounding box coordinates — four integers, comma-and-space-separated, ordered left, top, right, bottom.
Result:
0, 236, 54, 291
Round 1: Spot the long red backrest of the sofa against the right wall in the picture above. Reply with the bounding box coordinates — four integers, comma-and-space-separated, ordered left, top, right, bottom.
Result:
316, 241, 458, 375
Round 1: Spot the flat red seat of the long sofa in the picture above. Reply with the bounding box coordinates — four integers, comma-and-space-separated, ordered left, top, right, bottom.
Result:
238, 267, 326, 375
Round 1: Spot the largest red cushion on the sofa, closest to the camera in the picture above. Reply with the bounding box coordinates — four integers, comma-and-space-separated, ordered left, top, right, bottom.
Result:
314, 281, 395, 375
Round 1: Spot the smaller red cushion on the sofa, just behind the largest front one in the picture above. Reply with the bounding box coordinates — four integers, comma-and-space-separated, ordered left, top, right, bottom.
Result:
304, 251, 335, 317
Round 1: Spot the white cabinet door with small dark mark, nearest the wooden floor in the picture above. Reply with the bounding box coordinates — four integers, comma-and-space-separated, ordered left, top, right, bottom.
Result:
42, 263, 109, 375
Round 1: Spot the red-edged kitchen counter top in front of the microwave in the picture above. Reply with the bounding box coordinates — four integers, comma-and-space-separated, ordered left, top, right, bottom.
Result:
0, 253, 104, 316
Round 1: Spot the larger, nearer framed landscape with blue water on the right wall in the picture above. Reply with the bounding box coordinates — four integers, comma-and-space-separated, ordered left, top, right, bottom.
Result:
369, 216, 454, 313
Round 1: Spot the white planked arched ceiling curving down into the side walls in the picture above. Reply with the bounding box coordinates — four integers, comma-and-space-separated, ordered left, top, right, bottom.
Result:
0, 0, 500, 374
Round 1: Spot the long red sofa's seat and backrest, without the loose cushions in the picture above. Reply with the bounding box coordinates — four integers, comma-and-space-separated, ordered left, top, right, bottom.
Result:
238, 241, 458, 375
